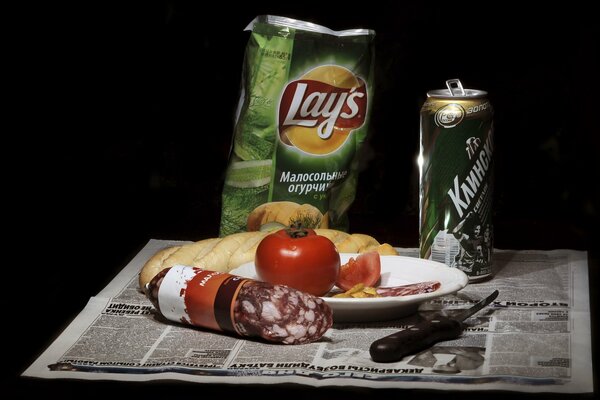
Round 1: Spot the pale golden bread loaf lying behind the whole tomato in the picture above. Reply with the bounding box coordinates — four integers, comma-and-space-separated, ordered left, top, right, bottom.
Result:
139, 229, 398, 290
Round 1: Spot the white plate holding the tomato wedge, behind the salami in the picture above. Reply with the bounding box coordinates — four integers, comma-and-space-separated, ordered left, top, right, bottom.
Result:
229, 253, 469, 322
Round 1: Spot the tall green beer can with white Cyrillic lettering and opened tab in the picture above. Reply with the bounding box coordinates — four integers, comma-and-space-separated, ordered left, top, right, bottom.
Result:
418, 79, 494, 281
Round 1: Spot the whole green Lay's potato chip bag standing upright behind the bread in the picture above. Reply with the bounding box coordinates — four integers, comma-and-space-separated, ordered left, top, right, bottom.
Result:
220, 15, 375, 236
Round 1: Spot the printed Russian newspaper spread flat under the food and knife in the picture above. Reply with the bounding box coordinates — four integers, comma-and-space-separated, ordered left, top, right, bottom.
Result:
23, 240, 593, 393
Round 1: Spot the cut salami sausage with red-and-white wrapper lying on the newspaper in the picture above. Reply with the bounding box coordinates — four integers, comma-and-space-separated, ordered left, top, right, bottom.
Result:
145, 265, 333, 344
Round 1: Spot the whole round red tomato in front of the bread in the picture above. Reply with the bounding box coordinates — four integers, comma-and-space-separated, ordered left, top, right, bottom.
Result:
254, 228, 340, 296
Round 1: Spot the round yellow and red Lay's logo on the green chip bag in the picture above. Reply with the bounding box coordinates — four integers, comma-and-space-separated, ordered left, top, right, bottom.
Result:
279, 65, 367, 154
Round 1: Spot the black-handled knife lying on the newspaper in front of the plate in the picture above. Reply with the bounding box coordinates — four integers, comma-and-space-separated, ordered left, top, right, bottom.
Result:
369, 290, 498, 362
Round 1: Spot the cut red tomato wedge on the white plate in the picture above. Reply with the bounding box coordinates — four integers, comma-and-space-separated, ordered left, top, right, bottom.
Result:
335, 251, 381, 290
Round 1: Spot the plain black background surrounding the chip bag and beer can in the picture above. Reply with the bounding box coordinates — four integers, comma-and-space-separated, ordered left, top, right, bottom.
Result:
8, 1, 600, 397
